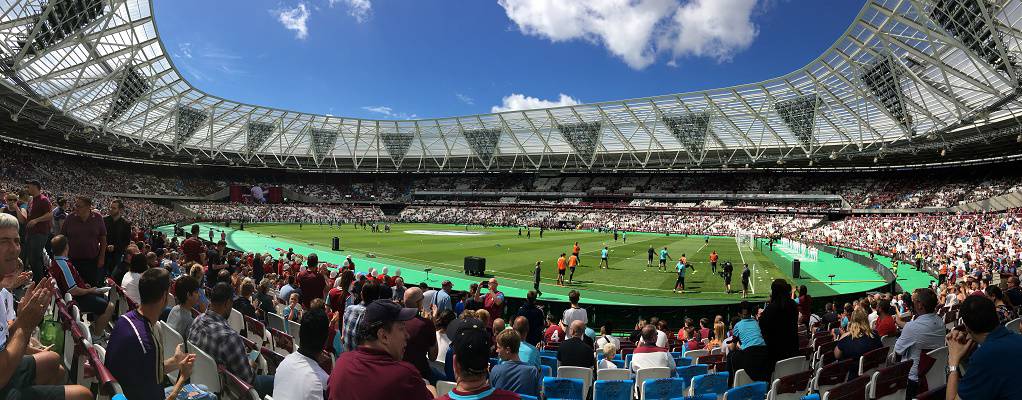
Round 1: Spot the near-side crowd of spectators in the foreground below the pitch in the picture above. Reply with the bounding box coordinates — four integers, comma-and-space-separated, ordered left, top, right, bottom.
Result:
0, 183, 1022, 399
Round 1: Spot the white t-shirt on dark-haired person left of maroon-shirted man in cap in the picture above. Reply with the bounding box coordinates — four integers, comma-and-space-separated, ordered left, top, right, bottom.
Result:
273, 352, 329, 400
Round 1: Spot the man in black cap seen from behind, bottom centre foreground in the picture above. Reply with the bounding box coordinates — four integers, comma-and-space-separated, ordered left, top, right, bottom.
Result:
438, 319, 520, 400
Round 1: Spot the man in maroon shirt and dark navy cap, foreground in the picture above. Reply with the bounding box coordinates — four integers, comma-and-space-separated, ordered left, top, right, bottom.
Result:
327, 299, 437, 400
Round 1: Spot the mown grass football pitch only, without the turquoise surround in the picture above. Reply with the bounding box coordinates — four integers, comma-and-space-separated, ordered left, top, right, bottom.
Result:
234, 224, 784, 305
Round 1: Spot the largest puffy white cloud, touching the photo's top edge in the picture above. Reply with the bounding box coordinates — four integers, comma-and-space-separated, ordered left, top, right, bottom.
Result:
498, 0, 758, 70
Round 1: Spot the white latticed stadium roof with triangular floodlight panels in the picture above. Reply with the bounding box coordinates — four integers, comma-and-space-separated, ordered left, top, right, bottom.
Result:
0, 0, 1022, 171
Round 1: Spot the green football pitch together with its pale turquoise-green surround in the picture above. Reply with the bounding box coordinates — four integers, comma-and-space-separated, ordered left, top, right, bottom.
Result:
159, 223, 915, 306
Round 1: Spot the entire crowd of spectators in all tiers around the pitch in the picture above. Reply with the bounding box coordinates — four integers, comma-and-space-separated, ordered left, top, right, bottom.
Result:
6, 145, 1022, 399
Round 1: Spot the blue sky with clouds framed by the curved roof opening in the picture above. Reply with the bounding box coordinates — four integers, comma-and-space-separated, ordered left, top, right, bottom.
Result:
154, 0, 862, 119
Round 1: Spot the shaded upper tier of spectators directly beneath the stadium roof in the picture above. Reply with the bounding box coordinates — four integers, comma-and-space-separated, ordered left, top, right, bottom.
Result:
12, 143, 1022, 211
